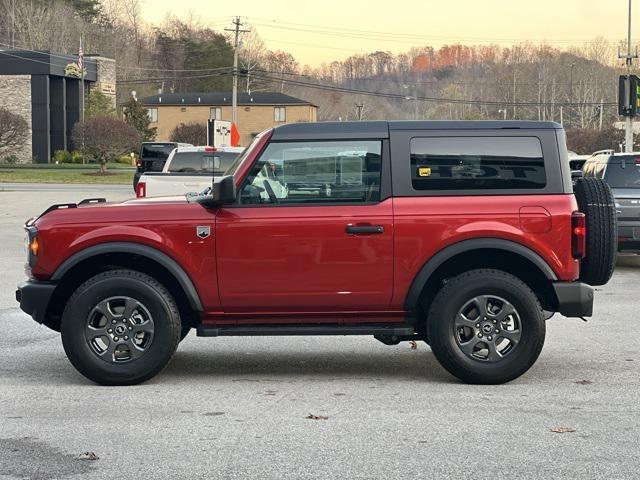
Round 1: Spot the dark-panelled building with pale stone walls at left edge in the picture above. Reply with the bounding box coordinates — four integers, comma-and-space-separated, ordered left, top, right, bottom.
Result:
0, 50, 116, 163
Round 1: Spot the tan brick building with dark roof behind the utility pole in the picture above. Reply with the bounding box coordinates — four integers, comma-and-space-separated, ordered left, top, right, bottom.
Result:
141, 92, 318, 146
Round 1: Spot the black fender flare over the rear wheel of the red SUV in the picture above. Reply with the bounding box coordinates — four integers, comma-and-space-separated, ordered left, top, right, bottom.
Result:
404, 238, 558, 311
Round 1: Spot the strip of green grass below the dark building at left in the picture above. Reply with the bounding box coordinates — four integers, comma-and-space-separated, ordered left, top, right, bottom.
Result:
0, 169, 133, 185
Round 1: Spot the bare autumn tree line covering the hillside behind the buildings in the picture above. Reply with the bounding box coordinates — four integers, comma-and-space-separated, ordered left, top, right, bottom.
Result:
0, 0, 622, 154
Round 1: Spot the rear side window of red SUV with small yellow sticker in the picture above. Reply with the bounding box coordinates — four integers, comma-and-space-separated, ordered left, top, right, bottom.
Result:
411, 137, 547, 190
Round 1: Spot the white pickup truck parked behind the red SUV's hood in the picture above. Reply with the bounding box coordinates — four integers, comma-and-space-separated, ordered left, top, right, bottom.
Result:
136, 147, 244, 198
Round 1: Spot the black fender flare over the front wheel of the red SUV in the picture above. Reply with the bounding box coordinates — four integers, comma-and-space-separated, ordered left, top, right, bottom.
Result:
50, 242, 203, 312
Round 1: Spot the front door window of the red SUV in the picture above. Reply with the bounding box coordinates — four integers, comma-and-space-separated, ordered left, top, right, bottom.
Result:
239, 140, 382, 205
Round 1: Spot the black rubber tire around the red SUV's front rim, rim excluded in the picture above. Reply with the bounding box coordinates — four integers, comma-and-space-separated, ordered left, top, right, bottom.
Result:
61, 270, 181, 385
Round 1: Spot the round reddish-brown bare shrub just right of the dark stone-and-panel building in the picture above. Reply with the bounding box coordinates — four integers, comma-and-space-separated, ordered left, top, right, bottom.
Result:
72, 116, 141, 173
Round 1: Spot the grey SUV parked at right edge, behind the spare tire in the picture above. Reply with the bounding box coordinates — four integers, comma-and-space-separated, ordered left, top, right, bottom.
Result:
583, 150, 640, 251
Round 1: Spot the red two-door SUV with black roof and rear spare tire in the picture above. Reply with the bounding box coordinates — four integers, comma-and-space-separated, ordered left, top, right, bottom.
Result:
16, 121, 616, 385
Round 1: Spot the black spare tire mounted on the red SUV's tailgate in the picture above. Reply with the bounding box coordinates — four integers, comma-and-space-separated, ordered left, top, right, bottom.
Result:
573, 177, 618, 286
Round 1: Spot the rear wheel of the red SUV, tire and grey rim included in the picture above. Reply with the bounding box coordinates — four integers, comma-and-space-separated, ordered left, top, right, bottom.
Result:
427, 269, 545, 384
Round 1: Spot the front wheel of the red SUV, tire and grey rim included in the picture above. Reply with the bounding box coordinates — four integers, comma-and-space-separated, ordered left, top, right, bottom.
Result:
61, 270, 181, 385
